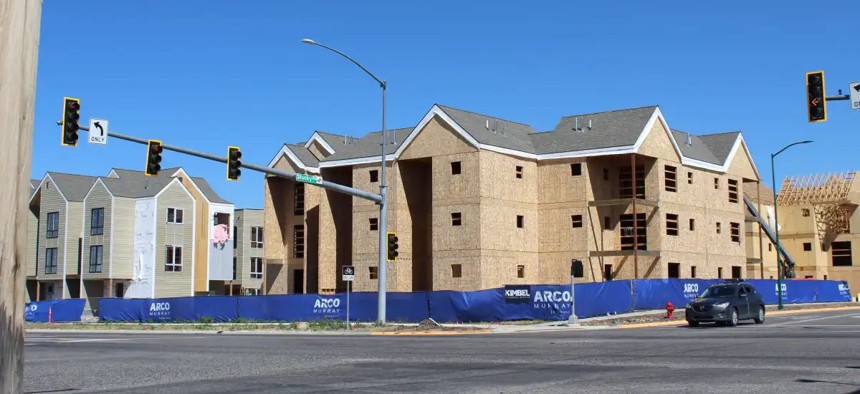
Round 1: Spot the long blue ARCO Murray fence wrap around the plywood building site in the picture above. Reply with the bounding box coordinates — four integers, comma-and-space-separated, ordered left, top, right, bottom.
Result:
90, 279, 851, 322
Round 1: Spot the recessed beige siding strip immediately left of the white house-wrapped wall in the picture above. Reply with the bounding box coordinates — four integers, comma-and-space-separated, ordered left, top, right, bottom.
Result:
109, 197, 135, 279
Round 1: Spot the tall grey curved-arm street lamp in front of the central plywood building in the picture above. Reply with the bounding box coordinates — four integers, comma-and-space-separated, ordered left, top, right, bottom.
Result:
302, 38, 388, 324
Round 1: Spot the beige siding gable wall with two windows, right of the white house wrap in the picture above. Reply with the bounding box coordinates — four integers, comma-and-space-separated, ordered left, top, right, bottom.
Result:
155, 183, 196, 297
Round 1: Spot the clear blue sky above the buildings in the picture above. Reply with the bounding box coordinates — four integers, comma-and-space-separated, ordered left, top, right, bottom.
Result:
32, 0, 860, 207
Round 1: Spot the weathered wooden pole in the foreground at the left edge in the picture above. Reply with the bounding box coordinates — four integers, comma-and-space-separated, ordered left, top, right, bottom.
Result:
0, 0, 41, 394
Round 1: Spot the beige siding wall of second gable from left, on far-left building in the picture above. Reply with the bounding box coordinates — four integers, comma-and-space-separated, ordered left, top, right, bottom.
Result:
81, 182, 113, 279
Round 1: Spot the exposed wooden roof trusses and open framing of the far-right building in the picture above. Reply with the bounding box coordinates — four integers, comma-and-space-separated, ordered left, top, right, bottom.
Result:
777, 171, 857, 250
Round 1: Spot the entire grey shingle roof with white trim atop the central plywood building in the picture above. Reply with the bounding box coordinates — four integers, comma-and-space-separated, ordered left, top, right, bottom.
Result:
269, 104, 758, 179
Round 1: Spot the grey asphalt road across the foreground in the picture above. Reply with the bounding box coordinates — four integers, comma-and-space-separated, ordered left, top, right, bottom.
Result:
25, 310, 860, 394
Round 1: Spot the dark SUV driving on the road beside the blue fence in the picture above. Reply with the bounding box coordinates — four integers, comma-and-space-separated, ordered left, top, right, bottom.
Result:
684, 281, 764, 327
